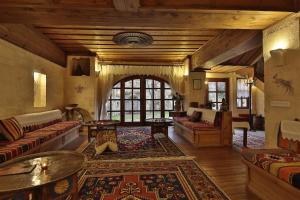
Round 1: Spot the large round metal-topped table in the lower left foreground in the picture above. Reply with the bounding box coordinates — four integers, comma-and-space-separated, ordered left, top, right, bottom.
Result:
0, 151, 84, 200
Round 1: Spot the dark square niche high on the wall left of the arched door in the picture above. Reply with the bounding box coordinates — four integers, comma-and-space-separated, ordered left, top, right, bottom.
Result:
71, 58, 91, 76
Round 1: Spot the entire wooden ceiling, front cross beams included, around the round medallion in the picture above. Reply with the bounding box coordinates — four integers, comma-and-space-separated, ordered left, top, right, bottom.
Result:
0, 0, 299, 62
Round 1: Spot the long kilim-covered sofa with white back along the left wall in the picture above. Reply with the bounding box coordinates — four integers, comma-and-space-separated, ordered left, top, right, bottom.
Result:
0, 110, 81, 163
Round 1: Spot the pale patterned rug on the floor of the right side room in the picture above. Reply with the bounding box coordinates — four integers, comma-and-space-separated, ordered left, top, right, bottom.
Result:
233, 130, 265, 150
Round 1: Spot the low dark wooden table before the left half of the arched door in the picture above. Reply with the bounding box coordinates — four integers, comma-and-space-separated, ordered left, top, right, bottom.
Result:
83, 120, 120, 142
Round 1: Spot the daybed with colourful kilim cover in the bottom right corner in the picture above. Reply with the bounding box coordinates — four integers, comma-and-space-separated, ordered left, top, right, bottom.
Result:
242, 121, 300, 200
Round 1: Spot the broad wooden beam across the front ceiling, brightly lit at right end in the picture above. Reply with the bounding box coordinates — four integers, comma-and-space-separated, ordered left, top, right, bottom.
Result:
0, 5, 291, 29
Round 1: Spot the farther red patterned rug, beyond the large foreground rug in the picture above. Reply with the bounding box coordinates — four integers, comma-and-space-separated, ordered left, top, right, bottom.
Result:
81, 127, 185, 161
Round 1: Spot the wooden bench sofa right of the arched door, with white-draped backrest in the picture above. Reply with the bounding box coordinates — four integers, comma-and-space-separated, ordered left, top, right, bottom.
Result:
174, 107, 232, 147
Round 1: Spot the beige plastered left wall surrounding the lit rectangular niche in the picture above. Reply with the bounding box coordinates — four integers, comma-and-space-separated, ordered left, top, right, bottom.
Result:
0, 39, 65, 118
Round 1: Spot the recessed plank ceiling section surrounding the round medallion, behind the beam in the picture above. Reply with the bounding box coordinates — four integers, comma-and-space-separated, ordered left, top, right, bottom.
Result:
37, 26, 221, 62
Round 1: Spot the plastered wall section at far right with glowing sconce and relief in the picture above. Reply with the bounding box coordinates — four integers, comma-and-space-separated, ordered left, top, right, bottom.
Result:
263, 15, 300, 148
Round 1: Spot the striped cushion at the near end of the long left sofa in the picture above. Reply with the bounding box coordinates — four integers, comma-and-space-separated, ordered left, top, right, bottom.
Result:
0, 118, 24, 142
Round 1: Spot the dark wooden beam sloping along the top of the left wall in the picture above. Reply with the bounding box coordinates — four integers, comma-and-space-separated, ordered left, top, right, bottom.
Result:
0, 24, 66, 67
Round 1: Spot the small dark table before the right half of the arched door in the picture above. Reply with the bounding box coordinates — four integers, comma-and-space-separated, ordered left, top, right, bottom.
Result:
146, 118, 173, 137
